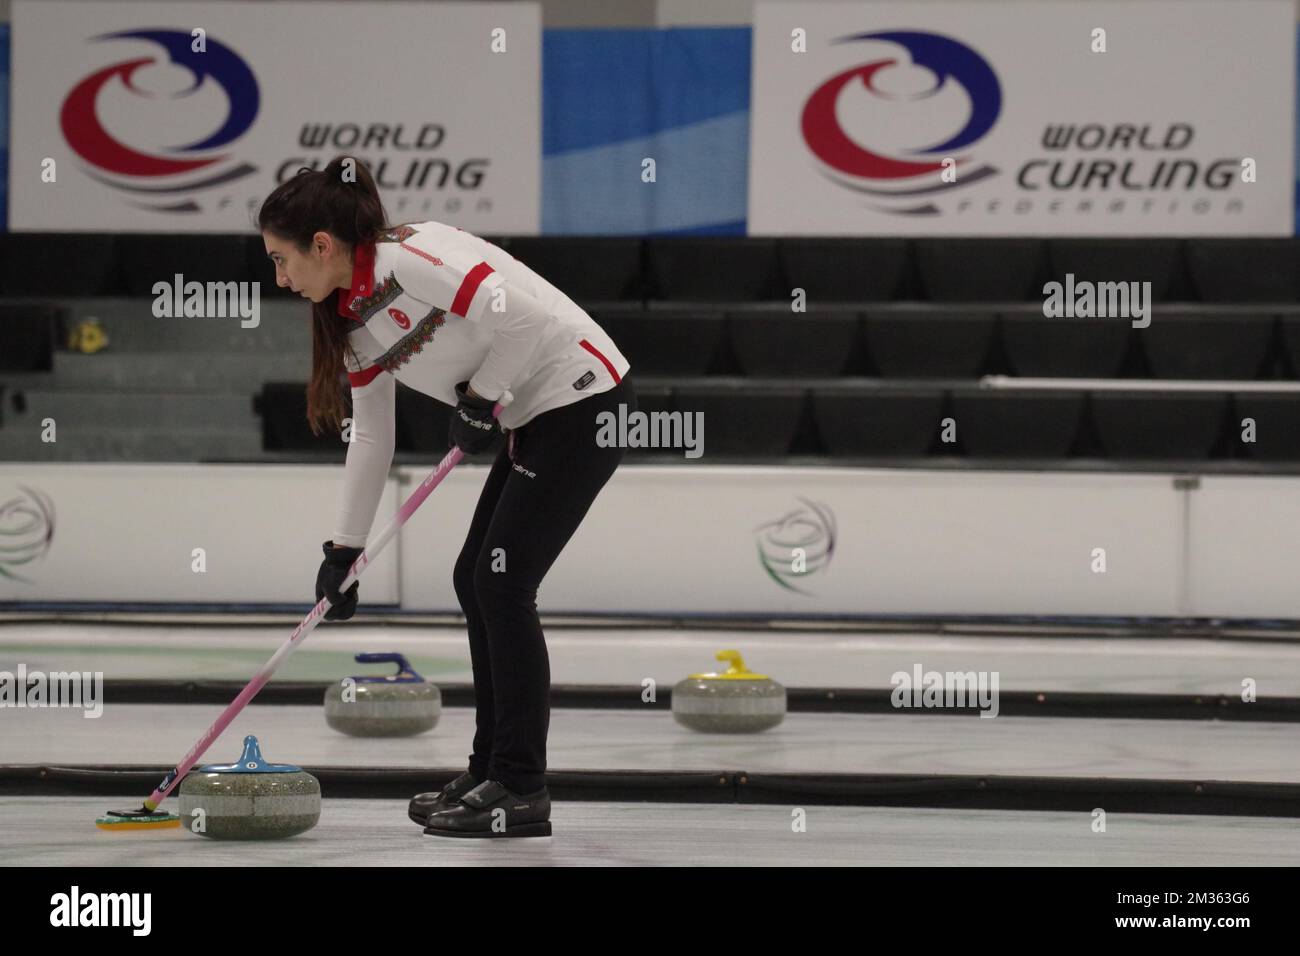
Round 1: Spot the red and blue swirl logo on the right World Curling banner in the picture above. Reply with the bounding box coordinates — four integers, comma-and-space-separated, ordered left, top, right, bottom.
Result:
800, 31, 1002, 213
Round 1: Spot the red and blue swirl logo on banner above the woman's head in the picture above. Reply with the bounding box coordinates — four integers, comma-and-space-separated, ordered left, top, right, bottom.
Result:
59, 30, 260, 212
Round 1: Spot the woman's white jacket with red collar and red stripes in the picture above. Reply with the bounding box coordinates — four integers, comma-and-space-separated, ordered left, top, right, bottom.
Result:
334, 221, 631, 548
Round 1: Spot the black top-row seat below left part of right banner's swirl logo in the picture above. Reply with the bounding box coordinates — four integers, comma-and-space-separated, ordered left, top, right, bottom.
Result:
776, 237, 907, 300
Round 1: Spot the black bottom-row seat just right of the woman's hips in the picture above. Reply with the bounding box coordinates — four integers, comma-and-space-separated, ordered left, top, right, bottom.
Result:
670, 382, 807, 463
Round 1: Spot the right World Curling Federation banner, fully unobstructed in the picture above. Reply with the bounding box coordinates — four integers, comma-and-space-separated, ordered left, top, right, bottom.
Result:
749, 0, 1295, 235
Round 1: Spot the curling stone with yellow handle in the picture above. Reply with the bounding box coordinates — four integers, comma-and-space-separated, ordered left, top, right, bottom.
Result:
672, 650, 785, 734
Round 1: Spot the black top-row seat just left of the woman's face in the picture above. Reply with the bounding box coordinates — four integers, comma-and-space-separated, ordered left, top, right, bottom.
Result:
117, 233, 250, 295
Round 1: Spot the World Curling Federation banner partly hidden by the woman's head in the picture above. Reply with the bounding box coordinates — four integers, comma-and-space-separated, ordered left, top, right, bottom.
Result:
9, 0, 541, 234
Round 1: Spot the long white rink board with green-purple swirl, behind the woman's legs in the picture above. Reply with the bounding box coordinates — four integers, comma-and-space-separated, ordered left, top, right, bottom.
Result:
402, 466, 1182, 615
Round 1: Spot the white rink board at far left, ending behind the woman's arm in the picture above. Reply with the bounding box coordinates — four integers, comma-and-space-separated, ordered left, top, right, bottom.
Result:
0, 464, 398, 614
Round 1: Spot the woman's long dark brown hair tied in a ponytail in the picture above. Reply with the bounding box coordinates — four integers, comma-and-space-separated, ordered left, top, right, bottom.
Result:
257, 156, 389, 434
